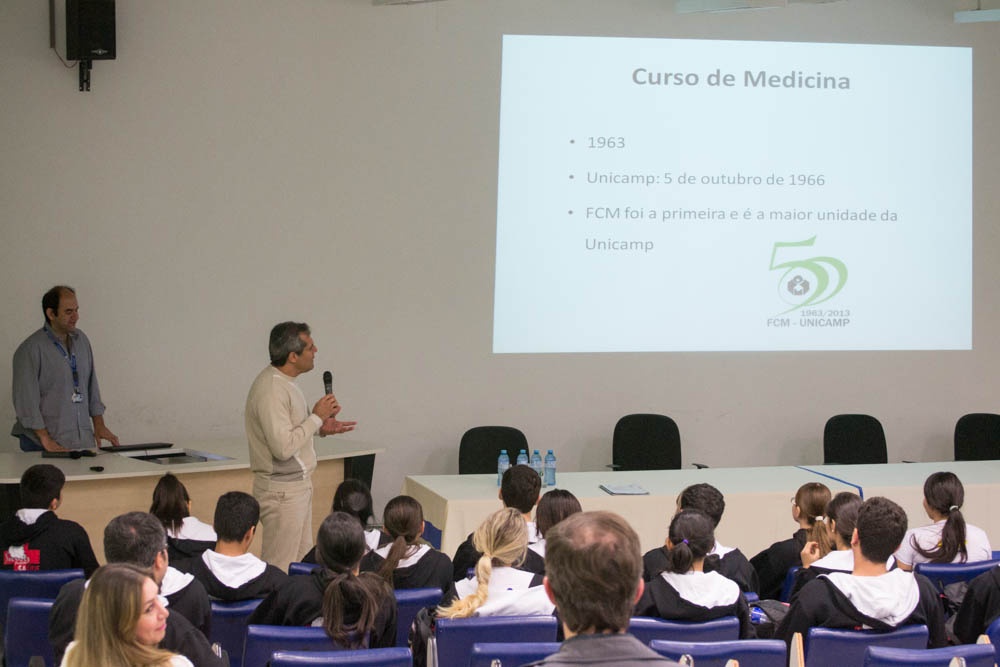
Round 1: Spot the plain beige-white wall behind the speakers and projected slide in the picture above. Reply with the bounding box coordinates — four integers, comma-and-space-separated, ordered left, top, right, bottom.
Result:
0, 0, 1000, 506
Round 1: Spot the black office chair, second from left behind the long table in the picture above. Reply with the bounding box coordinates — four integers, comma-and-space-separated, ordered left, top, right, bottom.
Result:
610, 414, 681, 470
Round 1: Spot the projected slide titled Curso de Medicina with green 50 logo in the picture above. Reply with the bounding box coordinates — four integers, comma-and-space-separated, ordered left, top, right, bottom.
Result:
493, 35, 972, 353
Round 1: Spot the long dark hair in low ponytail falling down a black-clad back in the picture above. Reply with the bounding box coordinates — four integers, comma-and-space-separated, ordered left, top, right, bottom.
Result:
316, 512, 391, 649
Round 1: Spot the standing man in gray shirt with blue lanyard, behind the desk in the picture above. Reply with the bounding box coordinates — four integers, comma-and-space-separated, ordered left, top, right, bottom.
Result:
11, 285, 118, 452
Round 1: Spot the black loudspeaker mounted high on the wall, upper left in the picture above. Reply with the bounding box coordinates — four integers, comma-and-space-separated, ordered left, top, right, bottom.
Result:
49, 0, 115, 61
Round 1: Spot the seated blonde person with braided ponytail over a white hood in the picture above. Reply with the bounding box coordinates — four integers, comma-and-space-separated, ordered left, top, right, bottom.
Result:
438, 506, 553, 618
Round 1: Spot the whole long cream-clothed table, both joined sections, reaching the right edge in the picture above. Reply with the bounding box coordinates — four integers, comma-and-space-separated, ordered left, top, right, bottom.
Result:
402, 461, 1000, 558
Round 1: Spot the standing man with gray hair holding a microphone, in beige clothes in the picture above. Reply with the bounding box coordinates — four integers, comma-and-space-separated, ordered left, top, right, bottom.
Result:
244, 322, 355, 570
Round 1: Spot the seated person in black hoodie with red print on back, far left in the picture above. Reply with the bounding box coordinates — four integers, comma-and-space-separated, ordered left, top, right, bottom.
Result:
0, 463, 97, 577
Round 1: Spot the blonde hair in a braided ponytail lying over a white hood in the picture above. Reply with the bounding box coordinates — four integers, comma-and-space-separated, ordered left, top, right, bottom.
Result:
438, 507, 528, 618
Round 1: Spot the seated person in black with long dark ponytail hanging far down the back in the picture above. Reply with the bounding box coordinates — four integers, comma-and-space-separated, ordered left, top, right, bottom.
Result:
248, 512, 396, 648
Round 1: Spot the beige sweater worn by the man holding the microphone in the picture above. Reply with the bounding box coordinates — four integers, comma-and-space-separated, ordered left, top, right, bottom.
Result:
245, 366, 323, 482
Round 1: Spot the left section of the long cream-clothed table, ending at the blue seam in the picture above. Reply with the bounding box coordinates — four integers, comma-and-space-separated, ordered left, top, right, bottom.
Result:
402, 466, 856, 558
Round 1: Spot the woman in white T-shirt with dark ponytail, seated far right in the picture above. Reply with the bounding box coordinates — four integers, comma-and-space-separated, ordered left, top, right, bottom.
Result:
896, 472, 993, 570
